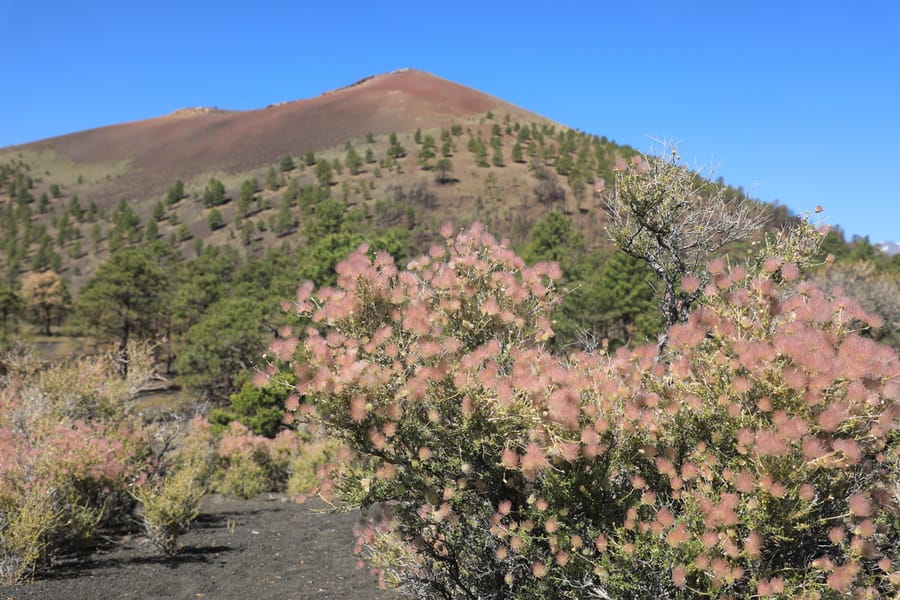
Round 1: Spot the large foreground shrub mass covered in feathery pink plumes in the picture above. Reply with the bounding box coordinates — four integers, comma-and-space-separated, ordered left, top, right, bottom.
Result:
276, 225, 900, 598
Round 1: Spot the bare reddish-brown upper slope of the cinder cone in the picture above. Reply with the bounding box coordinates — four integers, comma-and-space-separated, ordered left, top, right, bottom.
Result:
12, 70, 541, 195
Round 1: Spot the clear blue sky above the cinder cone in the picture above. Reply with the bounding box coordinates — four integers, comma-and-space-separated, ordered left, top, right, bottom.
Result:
0, 0, 900, 242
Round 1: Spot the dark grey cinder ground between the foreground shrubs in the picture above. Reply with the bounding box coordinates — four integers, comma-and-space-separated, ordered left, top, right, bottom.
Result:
0, 496, 402, 600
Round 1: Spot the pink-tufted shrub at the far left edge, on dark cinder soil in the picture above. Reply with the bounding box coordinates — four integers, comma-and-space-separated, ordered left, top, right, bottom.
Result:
0, 346, 152, 581
